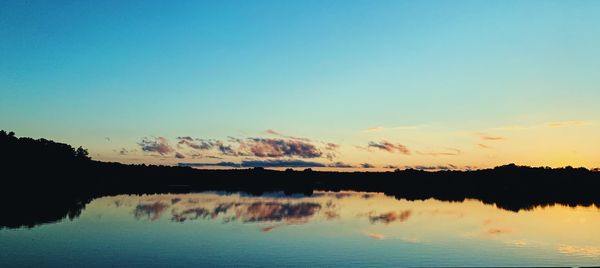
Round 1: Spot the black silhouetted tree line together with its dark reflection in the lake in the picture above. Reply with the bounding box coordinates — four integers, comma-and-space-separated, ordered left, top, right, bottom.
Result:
0, 131, 600, 227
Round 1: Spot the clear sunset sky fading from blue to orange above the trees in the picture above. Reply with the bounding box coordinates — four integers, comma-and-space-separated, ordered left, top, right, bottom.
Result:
0, 0, 600, 170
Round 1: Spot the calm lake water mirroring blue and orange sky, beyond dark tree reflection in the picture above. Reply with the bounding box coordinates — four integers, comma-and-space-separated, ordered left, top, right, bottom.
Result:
0, 192, 600, 267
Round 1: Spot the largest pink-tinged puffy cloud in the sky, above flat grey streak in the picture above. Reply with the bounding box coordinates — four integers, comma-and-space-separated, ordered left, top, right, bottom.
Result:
240, 138, 323, 158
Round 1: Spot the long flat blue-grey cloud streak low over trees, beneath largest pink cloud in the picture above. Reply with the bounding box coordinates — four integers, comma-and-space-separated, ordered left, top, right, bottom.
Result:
178, 159, 328, 168
